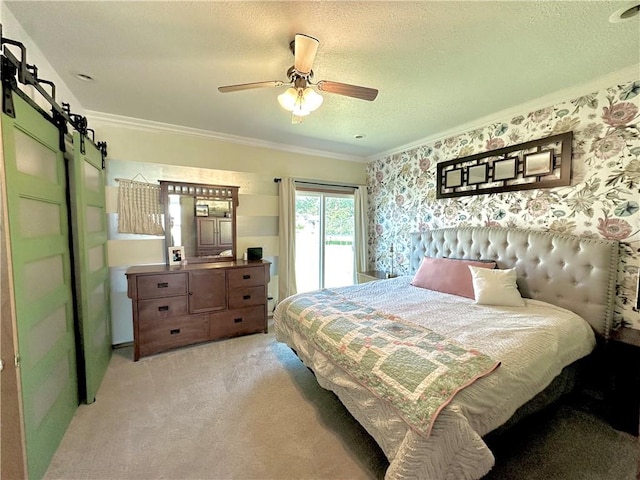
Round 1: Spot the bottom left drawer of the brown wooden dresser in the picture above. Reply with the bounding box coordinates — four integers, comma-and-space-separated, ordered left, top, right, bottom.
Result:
138, 316, 208, 356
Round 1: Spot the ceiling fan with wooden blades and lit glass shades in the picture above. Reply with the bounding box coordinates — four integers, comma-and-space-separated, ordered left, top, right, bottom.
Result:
218, 33, 378, 123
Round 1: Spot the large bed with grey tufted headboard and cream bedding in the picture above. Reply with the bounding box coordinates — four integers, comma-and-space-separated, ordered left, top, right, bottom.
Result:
274, 227, 618, 480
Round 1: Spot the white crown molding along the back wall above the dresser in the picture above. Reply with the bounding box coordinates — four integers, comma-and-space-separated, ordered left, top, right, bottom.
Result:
86, 110, 367, 163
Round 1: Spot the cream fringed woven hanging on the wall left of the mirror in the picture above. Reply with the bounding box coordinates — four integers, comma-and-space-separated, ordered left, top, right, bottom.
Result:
118, 180, 164, 235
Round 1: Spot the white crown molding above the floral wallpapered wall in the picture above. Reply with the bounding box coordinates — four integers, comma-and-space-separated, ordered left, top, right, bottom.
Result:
367, 64, 640, 162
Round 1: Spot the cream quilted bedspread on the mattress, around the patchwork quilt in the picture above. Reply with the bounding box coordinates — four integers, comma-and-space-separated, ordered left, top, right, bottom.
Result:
274, 276, 596, 480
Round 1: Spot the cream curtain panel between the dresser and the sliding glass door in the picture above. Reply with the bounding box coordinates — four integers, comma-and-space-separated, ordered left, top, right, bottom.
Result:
278, 178, 298, 301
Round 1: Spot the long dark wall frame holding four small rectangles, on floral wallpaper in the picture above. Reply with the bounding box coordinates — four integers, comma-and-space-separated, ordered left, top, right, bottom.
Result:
436, 132, 573, 198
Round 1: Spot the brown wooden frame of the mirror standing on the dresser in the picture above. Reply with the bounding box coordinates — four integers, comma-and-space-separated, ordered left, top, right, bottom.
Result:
159, 180, 240, 263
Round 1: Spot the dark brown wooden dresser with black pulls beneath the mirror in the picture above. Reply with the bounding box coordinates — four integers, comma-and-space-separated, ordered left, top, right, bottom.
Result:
126, 260, 270, 361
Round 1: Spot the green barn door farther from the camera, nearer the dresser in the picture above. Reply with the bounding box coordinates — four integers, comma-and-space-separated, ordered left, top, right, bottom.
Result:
69, 132, 111, 403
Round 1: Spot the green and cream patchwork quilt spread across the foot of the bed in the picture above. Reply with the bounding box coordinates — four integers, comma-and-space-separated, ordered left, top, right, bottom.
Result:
285, 290, 500, 437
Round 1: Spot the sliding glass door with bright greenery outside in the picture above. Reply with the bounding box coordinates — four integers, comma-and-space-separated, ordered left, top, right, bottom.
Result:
296, 189, 355, 292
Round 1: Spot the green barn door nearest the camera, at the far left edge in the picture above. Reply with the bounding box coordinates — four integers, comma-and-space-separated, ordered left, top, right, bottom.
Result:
2, 94, 78, 479
